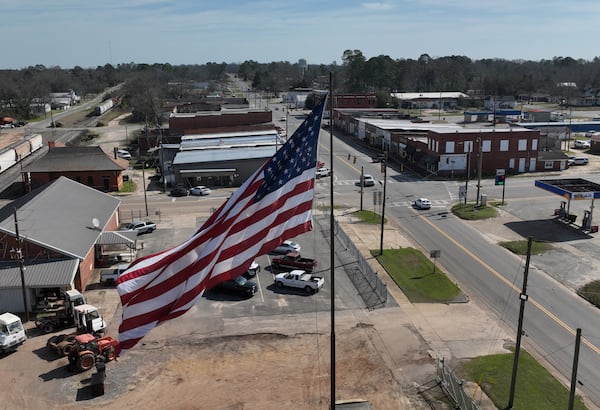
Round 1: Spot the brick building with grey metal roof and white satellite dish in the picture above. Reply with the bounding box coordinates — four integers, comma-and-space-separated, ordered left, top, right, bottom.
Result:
0, 177, 125, 311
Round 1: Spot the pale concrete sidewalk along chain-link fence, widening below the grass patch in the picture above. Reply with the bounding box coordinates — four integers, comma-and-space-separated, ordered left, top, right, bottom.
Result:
336, 211, 512, 409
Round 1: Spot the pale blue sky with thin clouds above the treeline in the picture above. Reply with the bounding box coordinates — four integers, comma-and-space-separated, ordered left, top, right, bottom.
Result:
0, 0, 600, 69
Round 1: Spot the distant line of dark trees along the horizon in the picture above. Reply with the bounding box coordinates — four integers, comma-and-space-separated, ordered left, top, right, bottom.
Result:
0, 50, 600, 124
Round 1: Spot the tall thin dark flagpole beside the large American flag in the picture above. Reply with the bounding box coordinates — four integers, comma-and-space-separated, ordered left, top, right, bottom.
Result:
325, 72, 335, 410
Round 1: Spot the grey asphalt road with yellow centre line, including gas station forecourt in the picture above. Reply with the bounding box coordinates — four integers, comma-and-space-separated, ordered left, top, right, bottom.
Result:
317, 130, 600, 407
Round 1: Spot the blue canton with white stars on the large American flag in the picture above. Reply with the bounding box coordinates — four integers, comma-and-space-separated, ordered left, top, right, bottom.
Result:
254, 98, 326, 201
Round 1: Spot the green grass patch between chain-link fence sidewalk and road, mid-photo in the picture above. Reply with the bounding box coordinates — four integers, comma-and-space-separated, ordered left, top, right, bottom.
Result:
371, 248, 461, 303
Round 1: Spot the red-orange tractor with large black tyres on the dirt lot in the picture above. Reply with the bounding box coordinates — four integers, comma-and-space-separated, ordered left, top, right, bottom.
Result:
69, 333, 118, 371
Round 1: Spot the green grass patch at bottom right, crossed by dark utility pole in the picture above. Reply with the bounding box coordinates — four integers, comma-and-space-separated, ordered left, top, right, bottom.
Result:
455, 350, 586, 410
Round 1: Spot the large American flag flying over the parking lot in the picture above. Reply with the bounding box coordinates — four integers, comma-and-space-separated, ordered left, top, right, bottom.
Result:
117, 98, 326, 352
